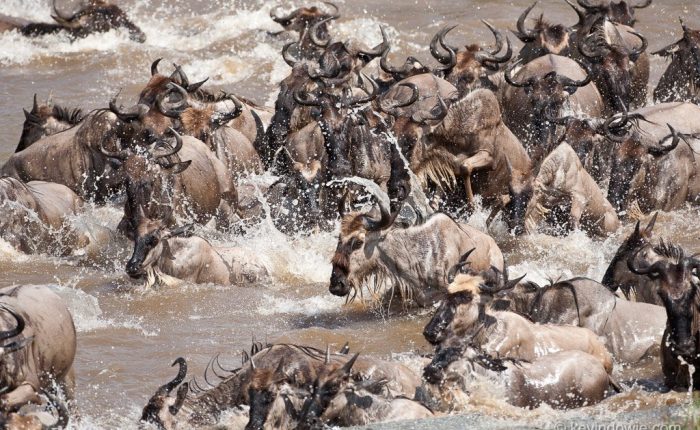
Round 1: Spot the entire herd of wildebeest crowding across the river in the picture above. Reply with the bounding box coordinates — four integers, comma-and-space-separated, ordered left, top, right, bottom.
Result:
0, 0, 700, 429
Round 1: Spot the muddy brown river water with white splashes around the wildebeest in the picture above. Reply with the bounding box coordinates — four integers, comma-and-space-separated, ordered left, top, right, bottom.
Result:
0, 0, 700, 428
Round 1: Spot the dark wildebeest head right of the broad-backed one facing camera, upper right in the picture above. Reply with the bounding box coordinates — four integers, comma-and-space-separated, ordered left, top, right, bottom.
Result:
578, 27, 648, 112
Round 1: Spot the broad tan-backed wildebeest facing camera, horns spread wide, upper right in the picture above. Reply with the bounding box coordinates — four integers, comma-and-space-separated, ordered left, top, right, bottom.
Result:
503, 54, 604, 159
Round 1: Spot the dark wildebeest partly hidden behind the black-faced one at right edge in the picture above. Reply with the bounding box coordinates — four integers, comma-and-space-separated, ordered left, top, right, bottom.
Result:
601, 213, 663, 306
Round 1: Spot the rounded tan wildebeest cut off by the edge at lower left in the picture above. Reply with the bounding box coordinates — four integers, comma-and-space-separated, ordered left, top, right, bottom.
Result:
0, 285, 76, 411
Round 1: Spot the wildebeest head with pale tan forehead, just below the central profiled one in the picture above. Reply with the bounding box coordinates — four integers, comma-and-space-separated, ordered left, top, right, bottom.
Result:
423, 255, 522, 345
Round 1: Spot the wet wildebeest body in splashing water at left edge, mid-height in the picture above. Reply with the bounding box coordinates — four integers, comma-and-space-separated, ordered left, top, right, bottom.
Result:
0, 176, 89, 255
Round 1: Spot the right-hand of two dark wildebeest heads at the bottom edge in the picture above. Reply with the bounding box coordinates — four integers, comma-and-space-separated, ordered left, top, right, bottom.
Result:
298, 353, 360, 429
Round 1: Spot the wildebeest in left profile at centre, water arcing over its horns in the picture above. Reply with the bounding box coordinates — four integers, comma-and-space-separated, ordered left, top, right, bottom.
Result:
329, 178, 504, 306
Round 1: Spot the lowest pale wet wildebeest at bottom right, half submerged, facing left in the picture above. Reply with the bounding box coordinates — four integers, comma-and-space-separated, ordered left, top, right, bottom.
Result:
424, 347, 613, 409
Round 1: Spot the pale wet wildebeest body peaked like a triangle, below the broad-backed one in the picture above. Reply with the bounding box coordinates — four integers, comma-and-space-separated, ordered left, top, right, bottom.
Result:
525, 142, 620, 236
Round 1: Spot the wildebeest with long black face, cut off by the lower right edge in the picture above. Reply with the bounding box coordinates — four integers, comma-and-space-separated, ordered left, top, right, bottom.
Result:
627, 242, 700, 389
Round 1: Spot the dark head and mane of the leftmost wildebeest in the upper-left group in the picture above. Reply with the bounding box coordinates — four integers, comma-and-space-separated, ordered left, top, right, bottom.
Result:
15, 94, 83, 152
